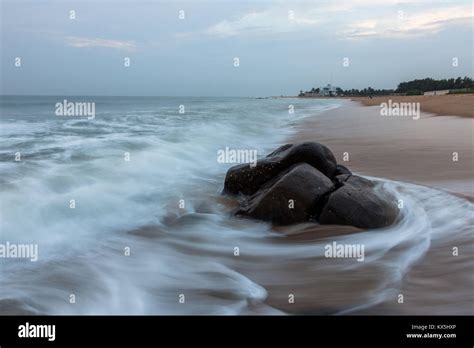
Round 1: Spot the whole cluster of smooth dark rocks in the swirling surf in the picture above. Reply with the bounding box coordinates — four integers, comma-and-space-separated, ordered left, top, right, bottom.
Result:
224, 142, 398, 228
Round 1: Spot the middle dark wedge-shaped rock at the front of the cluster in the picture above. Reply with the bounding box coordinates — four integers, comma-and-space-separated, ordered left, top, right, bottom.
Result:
237, 163, 334, 225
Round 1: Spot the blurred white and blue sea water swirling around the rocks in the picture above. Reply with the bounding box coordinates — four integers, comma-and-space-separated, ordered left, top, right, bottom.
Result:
0, 97, 473, 314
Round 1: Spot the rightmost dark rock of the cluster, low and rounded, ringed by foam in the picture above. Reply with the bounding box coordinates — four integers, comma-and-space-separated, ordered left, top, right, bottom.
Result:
319, 175, 398, 228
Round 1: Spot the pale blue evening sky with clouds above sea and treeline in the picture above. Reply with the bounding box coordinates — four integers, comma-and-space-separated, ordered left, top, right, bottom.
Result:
0, 0, 474, 97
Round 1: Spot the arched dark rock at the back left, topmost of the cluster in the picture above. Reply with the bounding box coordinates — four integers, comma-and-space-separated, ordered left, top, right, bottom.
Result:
224, 142, 337, 195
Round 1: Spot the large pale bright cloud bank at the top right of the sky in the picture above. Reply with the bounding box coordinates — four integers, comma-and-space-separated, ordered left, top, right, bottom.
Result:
198, 0, 473, 39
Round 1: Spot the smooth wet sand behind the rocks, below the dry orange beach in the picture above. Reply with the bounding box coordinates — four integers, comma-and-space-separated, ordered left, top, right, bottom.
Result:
291, 97, 474, 195
